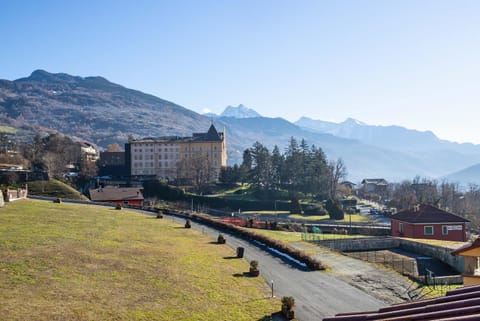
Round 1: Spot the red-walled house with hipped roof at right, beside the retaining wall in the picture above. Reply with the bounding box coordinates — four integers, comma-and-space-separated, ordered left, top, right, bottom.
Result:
391, 204, 469, 242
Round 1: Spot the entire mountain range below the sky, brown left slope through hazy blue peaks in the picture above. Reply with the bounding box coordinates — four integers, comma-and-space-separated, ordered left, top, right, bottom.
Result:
0, 70, 480, 184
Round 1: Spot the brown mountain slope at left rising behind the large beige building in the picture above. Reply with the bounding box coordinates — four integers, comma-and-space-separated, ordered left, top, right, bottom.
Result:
0, 70, 209, 146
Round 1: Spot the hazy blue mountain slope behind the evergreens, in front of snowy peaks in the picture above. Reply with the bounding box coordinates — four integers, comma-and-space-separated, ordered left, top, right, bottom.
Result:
219, 117, 436, 181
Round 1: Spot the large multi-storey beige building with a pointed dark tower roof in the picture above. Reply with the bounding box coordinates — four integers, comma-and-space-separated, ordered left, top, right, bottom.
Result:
125, 125, 227, 184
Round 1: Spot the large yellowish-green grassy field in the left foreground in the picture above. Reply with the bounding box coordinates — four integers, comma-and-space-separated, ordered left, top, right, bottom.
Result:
0, 200, 280, 321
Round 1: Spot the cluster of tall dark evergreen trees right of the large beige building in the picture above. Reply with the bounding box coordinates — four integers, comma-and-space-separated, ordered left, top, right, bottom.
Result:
219, 137, 347, 200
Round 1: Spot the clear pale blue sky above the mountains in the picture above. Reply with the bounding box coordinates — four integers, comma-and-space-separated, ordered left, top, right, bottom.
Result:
0, 0, 480, 144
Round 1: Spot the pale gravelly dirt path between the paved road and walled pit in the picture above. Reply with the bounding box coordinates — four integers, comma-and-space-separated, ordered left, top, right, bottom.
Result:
290, 242, 412, 304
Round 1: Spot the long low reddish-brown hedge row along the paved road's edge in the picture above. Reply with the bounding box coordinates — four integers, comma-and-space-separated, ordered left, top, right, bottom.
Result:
165, 211, 326, 270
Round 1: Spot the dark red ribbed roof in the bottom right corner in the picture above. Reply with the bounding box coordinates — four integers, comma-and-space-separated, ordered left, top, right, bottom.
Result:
323, 285, 480, 321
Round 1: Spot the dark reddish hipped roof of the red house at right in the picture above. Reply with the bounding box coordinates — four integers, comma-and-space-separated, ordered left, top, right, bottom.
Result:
391, 204, 470, 224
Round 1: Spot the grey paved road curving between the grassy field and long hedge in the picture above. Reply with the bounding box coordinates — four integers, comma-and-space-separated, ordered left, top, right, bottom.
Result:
161, 211, 387, 321
